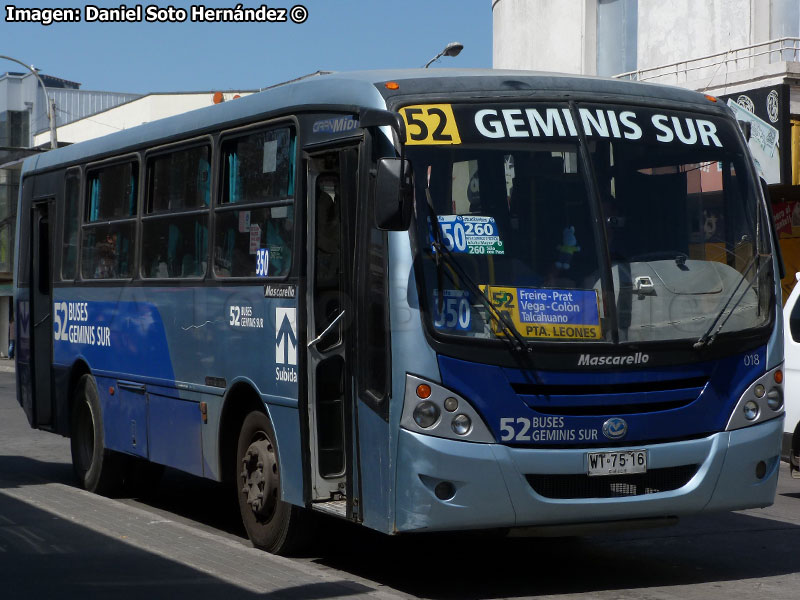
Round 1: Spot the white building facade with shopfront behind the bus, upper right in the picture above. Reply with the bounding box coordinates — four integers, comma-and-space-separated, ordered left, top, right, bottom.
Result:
491, 0, 800, 300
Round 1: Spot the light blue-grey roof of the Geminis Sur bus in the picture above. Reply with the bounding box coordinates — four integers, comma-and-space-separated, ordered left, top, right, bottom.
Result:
23, 68, 720, 172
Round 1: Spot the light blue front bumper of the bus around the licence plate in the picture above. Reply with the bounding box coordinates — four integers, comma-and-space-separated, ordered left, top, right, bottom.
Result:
395, 417, 783, 532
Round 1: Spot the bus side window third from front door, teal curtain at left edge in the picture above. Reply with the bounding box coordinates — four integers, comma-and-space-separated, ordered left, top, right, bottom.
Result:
81, 161, 139, 279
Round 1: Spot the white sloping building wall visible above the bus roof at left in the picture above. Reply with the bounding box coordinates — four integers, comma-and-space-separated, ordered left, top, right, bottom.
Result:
34, 92, 252, 146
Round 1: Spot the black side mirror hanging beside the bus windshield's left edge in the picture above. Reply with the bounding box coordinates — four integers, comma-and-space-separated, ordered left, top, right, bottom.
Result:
373, 158, 412, 231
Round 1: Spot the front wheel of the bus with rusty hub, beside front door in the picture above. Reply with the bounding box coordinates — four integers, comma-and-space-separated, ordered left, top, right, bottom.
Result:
235, 411, 313, 555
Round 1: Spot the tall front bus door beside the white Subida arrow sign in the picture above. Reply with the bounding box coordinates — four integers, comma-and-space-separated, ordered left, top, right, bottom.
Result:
306, 146, 358, 518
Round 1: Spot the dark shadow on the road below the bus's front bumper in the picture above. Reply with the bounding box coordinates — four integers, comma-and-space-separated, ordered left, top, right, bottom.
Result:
314, 513, 800, 600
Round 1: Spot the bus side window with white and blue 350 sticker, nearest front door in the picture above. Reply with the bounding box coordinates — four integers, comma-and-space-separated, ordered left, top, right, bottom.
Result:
213, 127, 295, 277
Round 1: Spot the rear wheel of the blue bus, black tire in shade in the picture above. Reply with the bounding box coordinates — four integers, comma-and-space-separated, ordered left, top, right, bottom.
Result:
70, 375, 124, 496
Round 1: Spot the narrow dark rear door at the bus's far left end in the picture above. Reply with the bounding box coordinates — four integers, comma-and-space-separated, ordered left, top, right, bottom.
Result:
28, 198, 55, 428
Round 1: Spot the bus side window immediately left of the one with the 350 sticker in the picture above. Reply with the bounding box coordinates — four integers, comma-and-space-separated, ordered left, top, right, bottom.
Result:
141, 146, 211, 278
